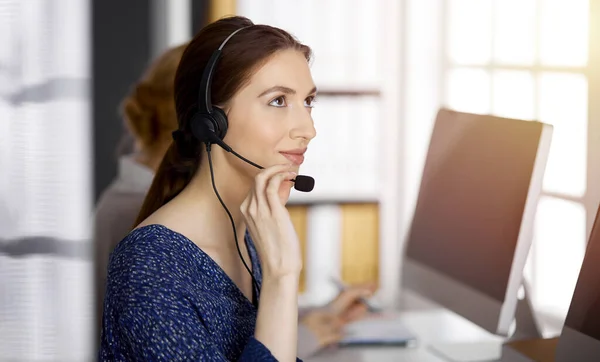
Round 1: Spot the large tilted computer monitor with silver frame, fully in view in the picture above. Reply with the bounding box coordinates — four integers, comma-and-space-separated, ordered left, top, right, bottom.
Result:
402, 109, 553, 360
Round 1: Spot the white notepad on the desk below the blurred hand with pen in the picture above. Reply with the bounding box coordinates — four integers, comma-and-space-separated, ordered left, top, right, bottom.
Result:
340, 313, 417, 346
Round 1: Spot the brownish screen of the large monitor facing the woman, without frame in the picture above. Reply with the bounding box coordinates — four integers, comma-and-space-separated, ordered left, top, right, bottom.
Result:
406, 110, 543, 301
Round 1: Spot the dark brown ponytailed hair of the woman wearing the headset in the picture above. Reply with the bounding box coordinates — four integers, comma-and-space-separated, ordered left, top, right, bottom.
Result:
136, 16, 311, 225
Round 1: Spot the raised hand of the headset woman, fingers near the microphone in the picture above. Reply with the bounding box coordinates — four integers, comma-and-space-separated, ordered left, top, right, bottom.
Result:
240, 165, 302, 280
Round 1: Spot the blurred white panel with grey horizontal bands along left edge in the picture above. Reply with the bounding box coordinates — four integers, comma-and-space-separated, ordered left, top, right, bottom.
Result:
0, 0, 95, 361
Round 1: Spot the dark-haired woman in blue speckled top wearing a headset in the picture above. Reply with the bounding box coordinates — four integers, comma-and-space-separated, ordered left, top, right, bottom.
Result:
100, 17, 369, 361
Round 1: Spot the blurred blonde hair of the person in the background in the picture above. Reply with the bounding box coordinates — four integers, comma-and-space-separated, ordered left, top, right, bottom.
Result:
121, 44, 187, 148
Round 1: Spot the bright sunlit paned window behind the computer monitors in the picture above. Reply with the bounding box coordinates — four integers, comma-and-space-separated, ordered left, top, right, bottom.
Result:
442, 0, 597, 317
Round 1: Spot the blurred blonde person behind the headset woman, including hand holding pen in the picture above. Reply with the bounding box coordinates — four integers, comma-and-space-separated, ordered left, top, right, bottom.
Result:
95, 36, 373, 358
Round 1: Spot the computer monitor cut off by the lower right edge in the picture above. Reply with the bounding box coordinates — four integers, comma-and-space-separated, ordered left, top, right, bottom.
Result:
555, 205, 600, 362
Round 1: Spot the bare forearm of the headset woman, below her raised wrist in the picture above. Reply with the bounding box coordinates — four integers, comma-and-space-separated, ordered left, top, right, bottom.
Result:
254, 275, 298, 362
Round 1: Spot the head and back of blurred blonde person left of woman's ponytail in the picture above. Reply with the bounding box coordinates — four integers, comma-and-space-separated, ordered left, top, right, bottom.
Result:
94, 44, 186, 346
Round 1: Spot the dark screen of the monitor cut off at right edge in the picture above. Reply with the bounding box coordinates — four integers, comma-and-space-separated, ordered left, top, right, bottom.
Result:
565, 210, 600, 341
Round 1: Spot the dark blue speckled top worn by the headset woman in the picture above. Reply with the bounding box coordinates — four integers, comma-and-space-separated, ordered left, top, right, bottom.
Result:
98, 225, 299, 361
